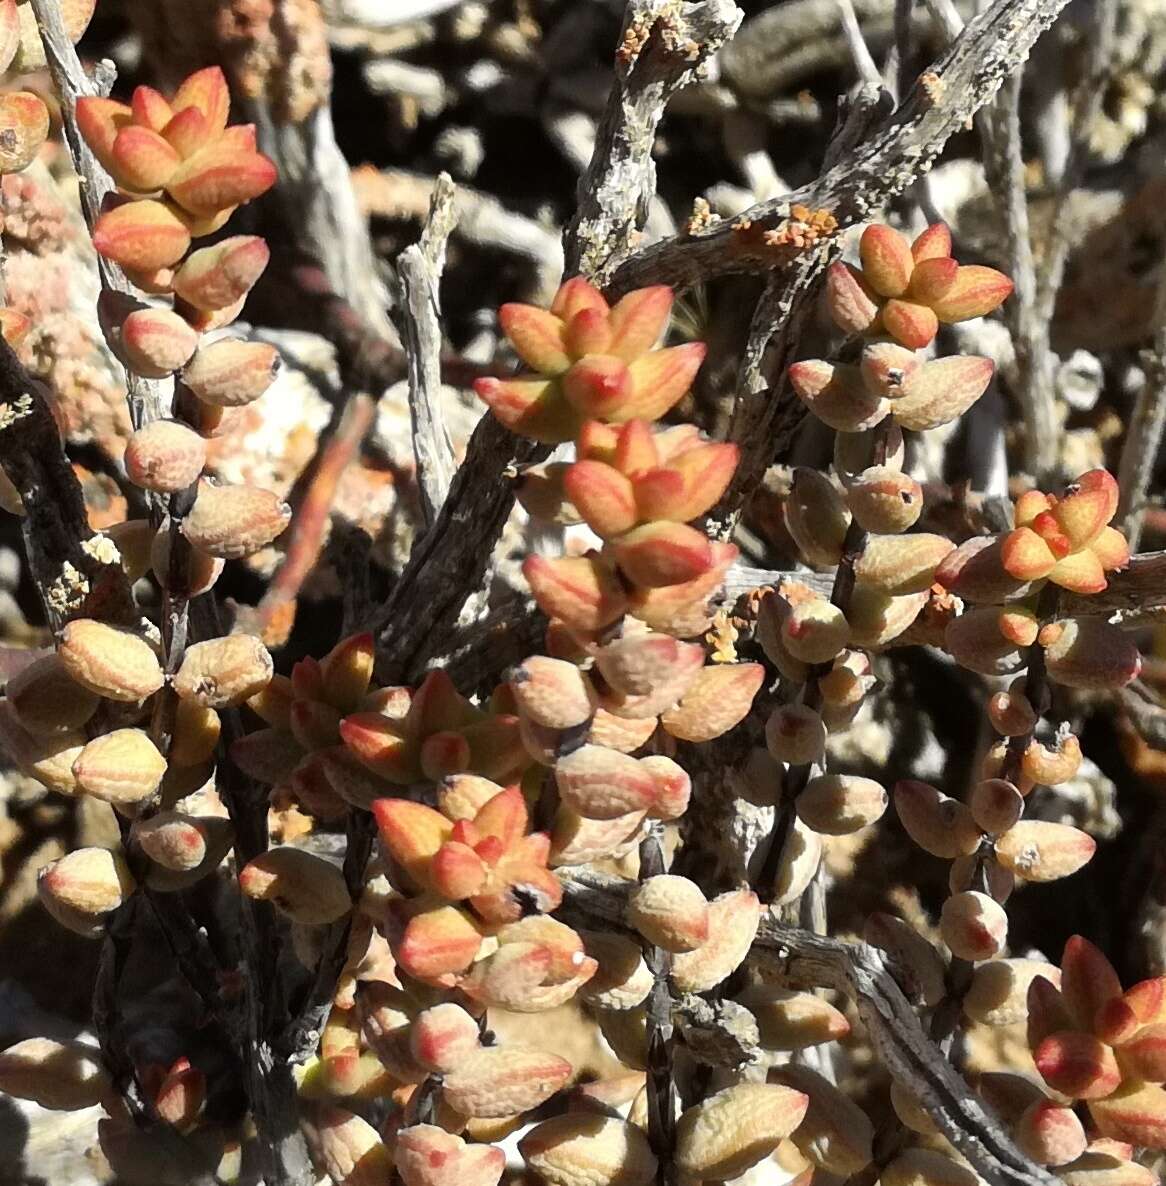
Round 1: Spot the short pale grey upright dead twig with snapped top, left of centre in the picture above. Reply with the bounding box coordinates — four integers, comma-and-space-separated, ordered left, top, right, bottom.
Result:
396, 173, 457, 527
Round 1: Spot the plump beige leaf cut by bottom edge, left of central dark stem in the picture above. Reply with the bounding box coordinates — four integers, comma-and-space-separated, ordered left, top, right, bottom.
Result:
518, 1112, 657, 1186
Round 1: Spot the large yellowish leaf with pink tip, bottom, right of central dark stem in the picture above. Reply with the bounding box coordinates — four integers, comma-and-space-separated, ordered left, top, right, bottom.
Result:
676, 1083, 809, 1180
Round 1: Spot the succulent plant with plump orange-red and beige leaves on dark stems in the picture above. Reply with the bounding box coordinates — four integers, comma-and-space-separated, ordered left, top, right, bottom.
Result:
0, 0, 1166, 1186
